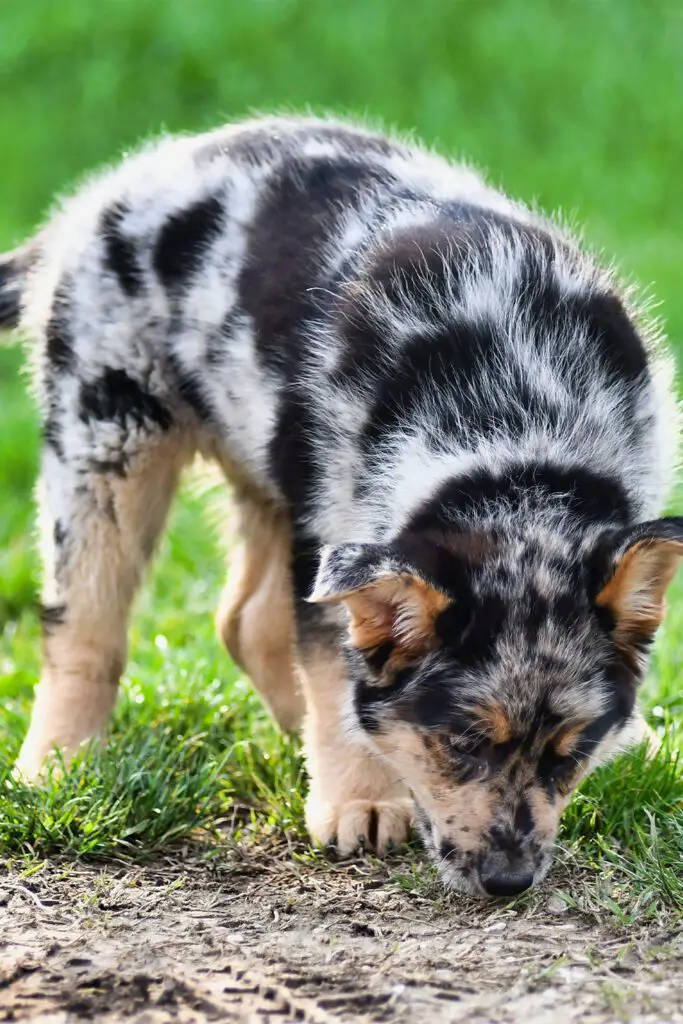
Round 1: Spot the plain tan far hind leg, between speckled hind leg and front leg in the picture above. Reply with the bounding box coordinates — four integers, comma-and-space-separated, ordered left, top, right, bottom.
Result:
216, 496, 303, 732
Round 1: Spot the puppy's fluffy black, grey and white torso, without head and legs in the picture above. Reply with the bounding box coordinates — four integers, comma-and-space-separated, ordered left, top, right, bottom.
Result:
2, 113, 676, 542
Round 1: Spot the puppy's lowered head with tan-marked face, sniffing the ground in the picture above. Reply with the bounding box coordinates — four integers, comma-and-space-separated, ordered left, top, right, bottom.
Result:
311, 519, 683, 896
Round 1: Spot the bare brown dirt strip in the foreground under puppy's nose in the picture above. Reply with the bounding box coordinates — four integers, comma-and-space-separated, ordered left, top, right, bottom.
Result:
0, 851, 683, 1024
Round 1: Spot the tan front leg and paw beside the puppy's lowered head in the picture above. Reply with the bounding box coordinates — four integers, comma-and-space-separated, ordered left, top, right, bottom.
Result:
299, 640, 413, 856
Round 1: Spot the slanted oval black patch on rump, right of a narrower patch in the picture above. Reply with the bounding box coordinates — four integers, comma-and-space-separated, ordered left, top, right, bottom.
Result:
153, 196, 225, 289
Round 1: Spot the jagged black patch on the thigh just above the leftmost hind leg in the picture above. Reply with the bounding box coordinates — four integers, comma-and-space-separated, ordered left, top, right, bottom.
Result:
80, 367, 173, 430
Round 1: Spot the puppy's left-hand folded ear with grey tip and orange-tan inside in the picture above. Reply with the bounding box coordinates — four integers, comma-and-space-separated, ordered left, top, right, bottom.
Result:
308, 544, 451, 655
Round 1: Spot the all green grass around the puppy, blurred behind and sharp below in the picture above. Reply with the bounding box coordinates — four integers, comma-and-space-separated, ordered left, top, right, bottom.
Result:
0, 0, 683, 915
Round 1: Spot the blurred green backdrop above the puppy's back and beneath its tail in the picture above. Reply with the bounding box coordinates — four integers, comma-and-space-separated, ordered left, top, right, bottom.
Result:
0, 0, 683, 655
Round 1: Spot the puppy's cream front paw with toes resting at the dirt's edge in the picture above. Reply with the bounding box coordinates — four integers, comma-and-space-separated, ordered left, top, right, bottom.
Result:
306, 798, 413, 857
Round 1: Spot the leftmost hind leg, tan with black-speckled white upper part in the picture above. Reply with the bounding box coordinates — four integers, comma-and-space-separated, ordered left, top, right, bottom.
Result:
16, 428, 193, 779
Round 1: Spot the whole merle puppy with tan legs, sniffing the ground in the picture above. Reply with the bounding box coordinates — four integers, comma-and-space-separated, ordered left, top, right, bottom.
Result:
0, 119, 683, 895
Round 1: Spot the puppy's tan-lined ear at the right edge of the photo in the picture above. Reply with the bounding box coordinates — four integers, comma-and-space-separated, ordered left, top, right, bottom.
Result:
592, 517, 683, 664
